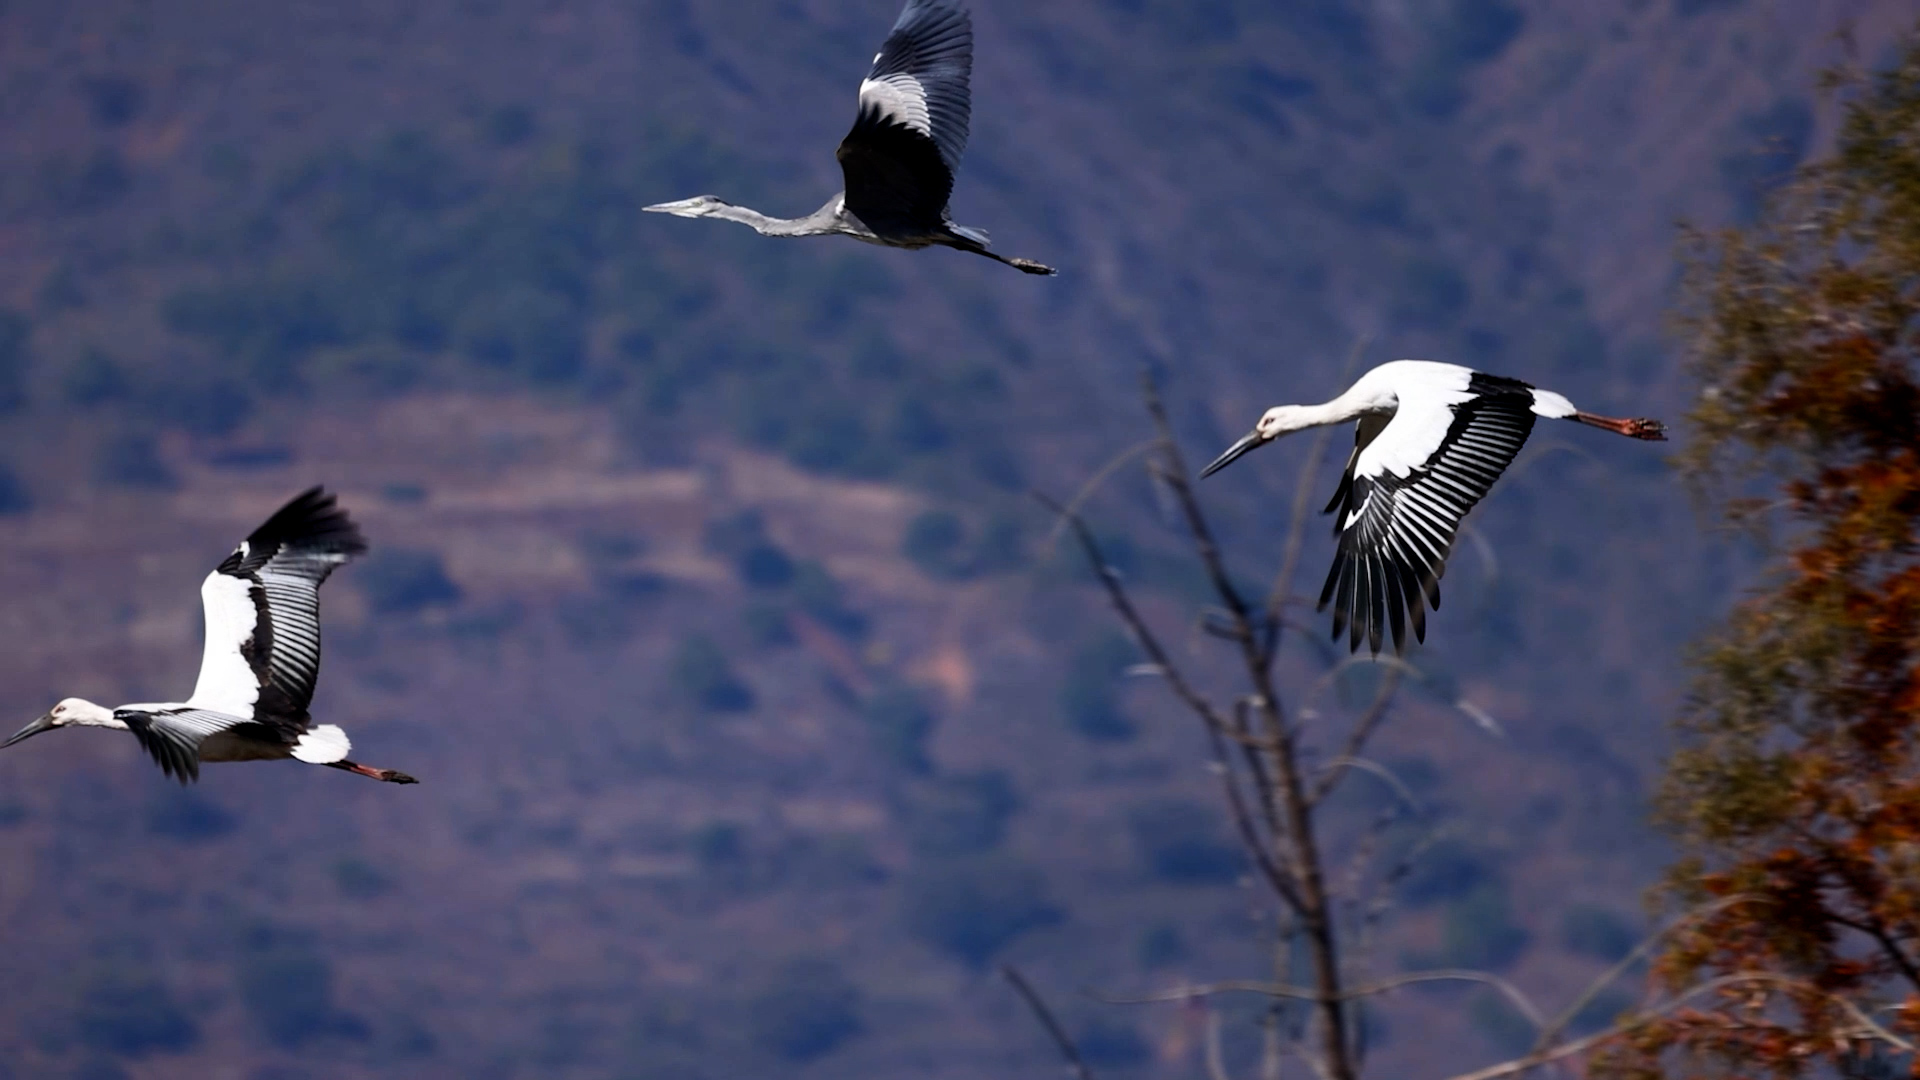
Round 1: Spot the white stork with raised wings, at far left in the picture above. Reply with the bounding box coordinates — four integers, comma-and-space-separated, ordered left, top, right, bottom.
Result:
0, 488, 419, 784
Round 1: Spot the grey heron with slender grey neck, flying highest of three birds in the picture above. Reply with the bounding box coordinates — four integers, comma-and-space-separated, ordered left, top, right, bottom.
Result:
645, 0, 1054, 275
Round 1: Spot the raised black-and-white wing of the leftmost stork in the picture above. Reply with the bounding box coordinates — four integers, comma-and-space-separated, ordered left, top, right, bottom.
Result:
186, 488, 367, 730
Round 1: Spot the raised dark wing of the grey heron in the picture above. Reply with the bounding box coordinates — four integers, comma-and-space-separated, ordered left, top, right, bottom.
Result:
835, 0, 973, 233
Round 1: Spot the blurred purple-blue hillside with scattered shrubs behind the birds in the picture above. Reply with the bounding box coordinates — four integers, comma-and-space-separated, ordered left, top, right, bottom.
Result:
0, 0, 1910, 1080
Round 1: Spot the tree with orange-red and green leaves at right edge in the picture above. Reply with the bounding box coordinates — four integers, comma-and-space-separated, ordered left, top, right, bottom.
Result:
1596, 33, 1920, 1078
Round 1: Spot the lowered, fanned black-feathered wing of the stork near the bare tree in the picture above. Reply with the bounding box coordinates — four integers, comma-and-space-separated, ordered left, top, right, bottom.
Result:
1319, 388, 1534, 653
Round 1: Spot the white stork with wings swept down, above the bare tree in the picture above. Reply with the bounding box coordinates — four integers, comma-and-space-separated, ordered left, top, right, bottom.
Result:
1200, 359, 1667, 653
